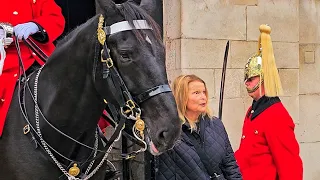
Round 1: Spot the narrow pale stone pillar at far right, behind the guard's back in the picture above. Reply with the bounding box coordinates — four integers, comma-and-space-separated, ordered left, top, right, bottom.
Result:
297, 0, 320, 180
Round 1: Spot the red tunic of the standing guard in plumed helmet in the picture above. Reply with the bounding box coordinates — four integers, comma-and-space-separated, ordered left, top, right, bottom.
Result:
235, 102, 303, 180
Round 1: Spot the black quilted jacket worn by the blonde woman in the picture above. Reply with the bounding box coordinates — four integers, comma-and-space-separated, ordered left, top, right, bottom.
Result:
155, 117, 242, 180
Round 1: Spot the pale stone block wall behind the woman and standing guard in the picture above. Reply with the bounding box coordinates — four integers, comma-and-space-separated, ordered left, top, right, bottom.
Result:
163, 0, 320, 180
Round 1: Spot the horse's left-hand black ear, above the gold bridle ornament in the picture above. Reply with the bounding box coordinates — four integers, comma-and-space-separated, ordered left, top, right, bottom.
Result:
95, 0, 118, 16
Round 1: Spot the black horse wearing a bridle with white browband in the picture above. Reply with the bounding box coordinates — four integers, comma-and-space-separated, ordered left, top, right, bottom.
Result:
0, 0, 180, 180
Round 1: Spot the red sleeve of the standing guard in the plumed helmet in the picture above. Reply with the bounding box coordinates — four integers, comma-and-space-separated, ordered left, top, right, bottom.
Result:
265, 114, 303, 180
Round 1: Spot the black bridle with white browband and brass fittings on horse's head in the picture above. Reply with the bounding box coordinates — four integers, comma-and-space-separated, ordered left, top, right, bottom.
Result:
94, 15, 171, 158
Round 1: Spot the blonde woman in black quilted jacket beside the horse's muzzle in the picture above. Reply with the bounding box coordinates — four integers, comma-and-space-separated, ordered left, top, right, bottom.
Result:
156, 75, 242, 180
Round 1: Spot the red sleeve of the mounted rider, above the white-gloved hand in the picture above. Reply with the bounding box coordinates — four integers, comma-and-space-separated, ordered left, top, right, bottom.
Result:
32, 0, 65, 43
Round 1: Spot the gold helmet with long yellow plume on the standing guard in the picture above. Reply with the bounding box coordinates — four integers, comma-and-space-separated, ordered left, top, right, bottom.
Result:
244, 24, 282, 97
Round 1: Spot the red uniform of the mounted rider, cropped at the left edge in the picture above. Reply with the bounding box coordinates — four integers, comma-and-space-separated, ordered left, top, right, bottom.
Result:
0, 0, 65, 136
